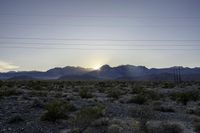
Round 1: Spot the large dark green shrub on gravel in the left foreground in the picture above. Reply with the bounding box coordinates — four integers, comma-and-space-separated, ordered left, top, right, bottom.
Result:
41, 100, 75, 122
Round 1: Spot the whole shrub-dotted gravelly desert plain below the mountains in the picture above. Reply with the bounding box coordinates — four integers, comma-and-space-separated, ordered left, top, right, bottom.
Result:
0, 81, 200, 133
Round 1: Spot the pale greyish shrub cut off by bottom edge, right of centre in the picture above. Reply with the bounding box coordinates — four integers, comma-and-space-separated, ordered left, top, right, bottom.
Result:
147, 122, 183, 133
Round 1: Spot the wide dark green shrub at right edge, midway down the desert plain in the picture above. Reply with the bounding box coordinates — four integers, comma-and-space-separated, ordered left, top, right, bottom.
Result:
171, 91, 199, 105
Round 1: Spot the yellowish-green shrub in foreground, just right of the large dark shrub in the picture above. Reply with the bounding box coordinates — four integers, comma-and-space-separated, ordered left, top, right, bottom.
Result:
72, 105, 105, 132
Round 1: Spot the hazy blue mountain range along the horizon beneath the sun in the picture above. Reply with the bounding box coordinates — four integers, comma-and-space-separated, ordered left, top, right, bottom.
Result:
0, 65, 200, 81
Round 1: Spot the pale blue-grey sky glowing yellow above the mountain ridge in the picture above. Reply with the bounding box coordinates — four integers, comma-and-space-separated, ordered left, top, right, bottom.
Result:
0, 0, 200, 72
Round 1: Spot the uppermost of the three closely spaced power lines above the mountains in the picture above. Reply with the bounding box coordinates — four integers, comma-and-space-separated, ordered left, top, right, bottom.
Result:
0, 37, 200, 42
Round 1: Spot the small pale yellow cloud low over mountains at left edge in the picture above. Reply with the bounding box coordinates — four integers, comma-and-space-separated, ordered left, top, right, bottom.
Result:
0, 61, 19, 72
